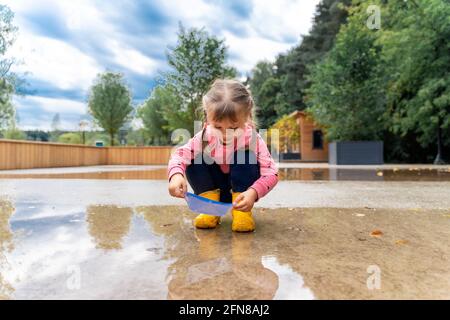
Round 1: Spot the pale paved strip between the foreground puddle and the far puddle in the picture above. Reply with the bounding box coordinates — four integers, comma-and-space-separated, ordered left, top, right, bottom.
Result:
0, 179, 450, 209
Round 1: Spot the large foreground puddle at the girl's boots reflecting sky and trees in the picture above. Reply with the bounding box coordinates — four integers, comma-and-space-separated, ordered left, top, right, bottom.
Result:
0, 200, 450, 299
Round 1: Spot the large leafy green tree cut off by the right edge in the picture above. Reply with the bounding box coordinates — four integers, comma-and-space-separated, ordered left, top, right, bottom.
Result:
380, 0, 450, 164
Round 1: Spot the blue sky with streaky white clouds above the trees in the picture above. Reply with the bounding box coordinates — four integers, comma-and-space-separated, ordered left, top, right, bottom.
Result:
1, 0, 319, 130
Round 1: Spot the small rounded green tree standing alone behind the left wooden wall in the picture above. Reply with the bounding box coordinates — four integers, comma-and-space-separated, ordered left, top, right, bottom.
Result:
88, 72, 133, 145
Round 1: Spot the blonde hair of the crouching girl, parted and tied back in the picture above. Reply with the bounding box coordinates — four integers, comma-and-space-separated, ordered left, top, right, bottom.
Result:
202, 79, 256, 127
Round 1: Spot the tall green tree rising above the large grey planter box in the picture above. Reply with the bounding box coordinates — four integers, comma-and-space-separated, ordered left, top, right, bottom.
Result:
306, 4, 386, 141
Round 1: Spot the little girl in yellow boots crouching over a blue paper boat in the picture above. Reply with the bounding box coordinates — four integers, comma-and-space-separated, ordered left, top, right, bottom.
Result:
168, 79, 278, 232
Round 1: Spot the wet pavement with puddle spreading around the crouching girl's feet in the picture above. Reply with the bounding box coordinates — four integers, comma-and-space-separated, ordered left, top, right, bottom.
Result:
0, 164, 450, 299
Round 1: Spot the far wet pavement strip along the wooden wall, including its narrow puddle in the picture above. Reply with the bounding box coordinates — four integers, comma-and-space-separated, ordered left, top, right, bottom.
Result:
0, 163, 450, 181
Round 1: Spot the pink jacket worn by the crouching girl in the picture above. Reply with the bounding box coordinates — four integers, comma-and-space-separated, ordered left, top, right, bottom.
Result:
167, 124, 278, 199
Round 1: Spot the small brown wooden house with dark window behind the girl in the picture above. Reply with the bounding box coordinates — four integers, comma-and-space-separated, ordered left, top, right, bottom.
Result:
289, 111, 328, 162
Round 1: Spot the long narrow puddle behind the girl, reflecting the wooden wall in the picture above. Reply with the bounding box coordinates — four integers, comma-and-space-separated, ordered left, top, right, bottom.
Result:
0, 167, 450, 181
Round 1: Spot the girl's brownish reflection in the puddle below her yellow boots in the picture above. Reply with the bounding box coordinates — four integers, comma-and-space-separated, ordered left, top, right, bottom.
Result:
137, 207, 278, 299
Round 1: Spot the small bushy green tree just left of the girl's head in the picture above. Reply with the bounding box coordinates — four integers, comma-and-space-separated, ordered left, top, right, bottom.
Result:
137, 86, 173, 145
